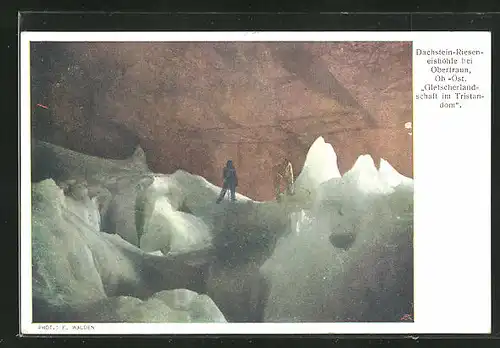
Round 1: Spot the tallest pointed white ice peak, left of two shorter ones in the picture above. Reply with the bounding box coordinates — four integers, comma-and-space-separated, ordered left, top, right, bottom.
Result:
296, 136, 340, 191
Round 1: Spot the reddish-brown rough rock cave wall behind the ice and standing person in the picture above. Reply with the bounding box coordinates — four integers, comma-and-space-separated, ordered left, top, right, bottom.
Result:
31, 42, 413, 200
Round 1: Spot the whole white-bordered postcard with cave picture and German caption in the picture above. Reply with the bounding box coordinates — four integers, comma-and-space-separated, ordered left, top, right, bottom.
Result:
20, 31, 491, 335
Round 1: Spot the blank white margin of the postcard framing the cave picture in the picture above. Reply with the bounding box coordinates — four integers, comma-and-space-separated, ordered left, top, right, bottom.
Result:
20, 31, 491, 335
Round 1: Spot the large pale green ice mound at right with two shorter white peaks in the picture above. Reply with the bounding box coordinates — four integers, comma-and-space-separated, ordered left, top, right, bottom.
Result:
262, 149, 413, 322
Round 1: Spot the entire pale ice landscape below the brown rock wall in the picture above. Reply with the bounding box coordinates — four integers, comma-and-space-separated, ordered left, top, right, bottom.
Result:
32, 137, 413, 322
